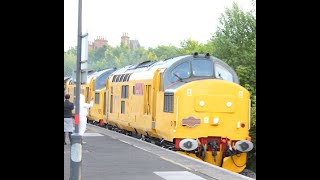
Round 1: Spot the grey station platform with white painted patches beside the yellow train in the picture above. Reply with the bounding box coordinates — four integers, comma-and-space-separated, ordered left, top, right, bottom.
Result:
64, 124, 252, 180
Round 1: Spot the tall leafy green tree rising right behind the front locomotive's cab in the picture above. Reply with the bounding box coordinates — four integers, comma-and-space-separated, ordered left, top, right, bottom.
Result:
208, 1, 256, 171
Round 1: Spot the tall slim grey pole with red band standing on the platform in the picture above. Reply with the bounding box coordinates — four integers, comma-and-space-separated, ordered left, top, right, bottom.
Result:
70, 0, 82, 180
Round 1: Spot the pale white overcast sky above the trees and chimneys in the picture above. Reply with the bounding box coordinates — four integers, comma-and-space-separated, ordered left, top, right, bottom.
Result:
64, 0, 253, 51
